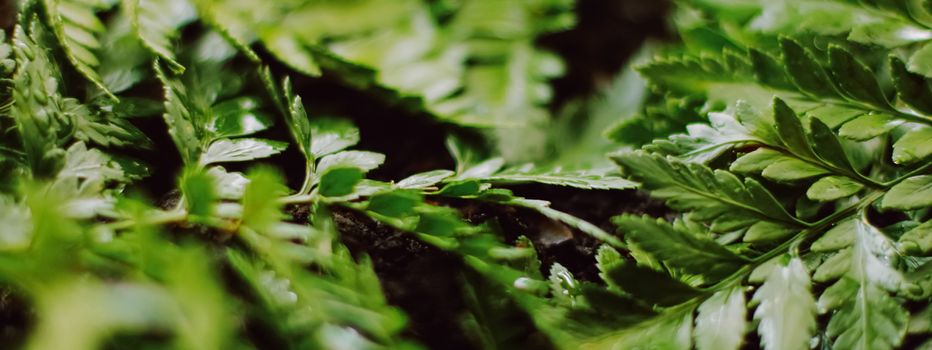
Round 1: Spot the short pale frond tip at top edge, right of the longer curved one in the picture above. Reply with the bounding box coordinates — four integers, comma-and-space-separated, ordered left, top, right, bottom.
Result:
123, 0, 194, 74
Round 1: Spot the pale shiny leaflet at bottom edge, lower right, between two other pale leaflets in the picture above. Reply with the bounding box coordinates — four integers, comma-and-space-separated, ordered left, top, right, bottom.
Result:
753, 258, 816, 350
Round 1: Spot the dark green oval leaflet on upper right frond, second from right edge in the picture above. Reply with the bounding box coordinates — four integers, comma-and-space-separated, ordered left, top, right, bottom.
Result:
828, 46, 890, 108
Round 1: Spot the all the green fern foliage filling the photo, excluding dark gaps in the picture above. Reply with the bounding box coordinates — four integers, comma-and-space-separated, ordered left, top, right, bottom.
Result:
0, 0, 932, 349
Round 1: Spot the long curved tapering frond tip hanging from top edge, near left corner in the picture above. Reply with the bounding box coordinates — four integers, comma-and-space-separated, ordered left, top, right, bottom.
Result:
44, 0, 116, 99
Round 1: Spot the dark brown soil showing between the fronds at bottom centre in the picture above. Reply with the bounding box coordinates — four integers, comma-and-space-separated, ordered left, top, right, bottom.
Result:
333, 186, 669, 349
